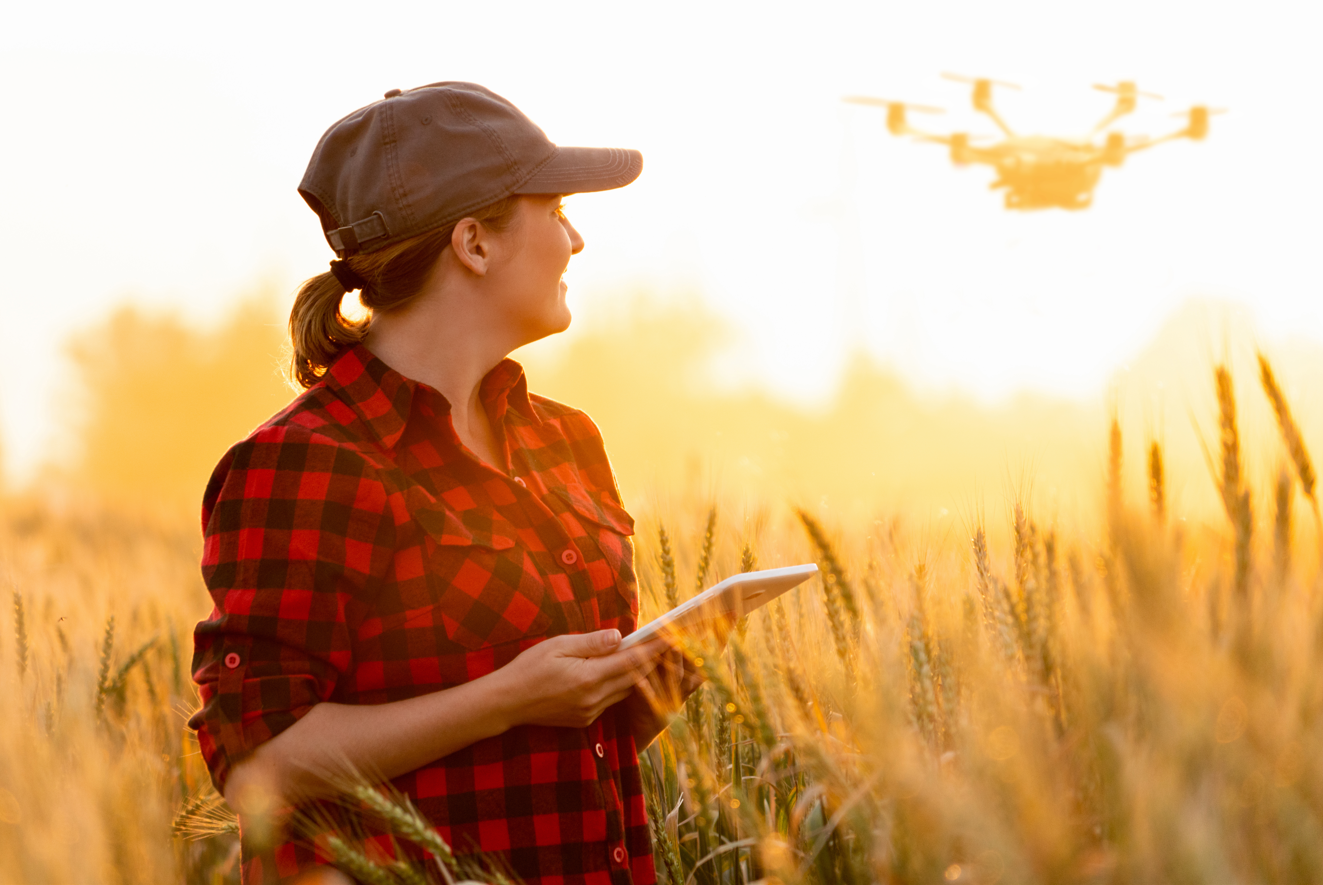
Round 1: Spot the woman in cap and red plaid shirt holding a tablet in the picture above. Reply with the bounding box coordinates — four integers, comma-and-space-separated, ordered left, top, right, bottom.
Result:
191, 82, 697, 885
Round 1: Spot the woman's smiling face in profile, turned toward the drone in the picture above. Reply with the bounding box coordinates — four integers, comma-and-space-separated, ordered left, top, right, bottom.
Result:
492, 194, 583, 341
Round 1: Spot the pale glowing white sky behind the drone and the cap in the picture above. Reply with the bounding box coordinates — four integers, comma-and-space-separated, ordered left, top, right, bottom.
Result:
0, 0, 1323, 479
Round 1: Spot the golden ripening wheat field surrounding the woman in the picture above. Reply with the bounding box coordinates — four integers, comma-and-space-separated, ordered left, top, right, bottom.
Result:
0, 346, 1323, 885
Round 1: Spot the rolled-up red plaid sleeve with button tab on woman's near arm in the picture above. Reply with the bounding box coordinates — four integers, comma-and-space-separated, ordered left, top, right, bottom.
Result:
189, 425, 394, 791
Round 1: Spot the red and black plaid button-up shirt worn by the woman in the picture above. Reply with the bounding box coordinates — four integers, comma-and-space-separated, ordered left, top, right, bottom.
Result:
189, 347, 655, 885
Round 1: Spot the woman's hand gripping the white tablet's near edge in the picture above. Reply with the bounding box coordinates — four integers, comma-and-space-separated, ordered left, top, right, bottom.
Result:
492, 630, 668, 728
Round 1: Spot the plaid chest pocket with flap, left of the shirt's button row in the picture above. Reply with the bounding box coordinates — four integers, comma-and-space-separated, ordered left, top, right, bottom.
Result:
415, 509, 552, 648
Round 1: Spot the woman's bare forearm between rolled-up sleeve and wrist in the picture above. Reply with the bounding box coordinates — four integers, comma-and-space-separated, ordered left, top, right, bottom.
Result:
225, 671, 515, 810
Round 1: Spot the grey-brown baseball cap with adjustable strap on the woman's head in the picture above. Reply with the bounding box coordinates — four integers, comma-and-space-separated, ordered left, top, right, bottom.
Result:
299, 82, 643, 258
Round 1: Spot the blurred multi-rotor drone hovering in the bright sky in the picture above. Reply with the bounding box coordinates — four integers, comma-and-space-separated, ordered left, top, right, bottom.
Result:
844, 74, 1225, 210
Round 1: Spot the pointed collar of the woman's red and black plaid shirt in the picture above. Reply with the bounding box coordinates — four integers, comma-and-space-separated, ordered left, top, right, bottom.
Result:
324, 344, 542, 448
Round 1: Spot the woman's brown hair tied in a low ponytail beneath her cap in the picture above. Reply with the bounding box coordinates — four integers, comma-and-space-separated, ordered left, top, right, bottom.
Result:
290, 196, 519, 388
